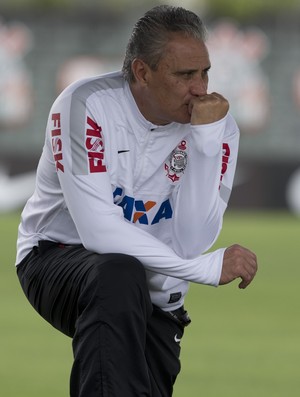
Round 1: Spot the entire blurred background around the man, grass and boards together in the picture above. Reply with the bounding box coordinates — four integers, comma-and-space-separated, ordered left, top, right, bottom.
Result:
0, 0, 300, 397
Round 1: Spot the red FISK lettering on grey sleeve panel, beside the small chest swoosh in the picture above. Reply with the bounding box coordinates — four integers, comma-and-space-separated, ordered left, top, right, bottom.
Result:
85, 117, 106, 172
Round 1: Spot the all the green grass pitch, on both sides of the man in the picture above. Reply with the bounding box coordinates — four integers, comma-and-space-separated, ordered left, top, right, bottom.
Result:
0, 212, 300, 397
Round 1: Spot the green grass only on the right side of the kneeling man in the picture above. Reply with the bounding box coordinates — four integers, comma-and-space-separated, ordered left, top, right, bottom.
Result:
175, 212, 300, 397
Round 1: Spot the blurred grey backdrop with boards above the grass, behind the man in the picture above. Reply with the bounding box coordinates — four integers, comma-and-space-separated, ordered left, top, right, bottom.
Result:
0, 0, 300, 213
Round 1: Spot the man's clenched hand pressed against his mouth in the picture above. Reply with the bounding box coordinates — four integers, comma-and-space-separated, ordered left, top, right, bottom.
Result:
189, 92, 229, 125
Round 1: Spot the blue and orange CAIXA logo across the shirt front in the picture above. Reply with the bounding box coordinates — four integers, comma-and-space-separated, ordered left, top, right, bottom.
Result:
113, 187, 173, 225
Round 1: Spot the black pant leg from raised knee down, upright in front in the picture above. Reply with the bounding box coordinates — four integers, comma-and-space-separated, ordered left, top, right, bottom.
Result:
71, 252, 152, 397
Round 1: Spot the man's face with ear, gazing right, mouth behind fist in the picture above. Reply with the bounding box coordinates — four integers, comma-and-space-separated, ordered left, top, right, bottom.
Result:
143, 33, 210, 125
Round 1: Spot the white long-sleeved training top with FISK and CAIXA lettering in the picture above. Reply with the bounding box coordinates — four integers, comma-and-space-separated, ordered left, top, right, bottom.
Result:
16, 72, 239, 310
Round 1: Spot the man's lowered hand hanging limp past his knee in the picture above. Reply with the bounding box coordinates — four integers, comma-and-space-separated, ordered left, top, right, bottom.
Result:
219, 244, 257, 288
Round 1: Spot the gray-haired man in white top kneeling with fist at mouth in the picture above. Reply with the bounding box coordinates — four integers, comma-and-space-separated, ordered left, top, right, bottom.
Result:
17, 6, 257, 397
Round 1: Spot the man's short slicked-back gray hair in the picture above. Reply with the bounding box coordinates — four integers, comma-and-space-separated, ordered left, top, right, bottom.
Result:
122, 5, 206, 82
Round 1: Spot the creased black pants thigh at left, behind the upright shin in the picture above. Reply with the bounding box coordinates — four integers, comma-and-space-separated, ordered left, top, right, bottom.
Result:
17, 241, 94, 337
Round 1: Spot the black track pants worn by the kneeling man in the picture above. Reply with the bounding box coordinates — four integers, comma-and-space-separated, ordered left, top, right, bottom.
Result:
17, 242, 183, 397
